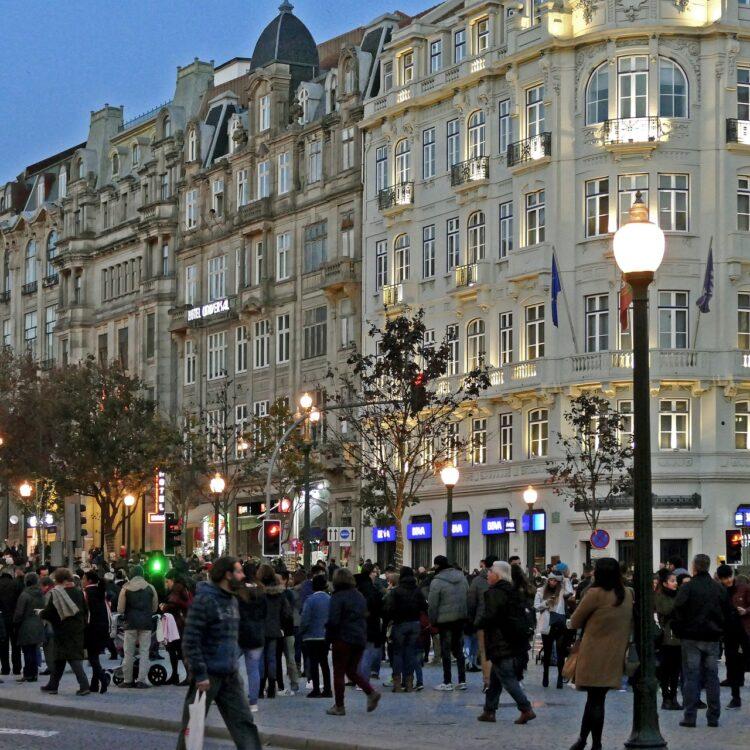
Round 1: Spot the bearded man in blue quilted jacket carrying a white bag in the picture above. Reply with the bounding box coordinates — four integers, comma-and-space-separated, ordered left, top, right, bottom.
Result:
177, 557, 260, 750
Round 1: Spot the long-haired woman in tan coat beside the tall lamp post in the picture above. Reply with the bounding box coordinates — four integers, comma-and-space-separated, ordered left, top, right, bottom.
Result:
570, 557, 633, 750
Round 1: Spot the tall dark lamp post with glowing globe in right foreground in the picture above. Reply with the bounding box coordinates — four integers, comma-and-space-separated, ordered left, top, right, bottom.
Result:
613, 191, 667, 748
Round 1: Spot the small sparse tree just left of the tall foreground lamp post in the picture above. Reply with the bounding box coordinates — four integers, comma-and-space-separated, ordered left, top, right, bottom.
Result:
547, 392, 633, 531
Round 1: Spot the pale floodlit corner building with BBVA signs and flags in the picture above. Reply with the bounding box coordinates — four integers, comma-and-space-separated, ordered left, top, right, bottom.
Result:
361, 0, 750, 569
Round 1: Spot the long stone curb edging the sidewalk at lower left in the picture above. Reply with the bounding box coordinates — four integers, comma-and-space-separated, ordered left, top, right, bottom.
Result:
0, 696, 403, 750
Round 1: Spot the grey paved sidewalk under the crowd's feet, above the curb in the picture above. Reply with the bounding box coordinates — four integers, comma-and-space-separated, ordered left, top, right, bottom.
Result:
0, 663, 750, 750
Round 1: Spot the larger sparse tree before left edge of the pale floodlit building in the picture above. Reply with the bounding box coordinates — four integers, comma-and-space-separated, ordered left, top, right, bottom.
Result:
328, 310, 490, 564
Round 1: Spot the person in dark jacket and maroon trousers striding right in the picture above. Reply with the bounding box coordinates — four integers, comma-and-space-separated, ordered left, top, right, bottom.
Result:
326, 568, 380, 716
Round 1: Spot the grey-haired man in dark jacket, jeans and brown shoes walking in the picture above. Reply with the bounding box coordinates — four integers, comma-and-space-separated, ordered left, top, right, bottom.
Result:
477, 561, 536, 724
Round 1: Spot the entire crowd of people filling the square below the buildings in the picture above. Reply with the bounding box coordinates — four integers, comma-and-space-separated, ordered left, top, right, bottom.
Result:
0, 550, 750, 750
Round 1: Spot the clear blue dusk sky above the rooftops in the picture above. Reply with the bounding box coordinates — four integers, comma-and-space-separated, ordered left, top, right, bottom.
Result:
0, 0, 434, 184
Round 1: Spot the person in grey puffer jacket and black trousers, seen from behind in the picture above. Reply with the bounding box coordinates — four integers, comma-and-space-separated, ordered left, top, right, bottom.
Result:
428, 555, 469, 691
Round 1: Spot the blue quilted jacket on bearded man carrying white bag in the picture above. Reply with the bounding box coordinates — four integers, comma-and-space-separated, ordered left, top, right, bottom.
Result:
182, 581, 240, 682
